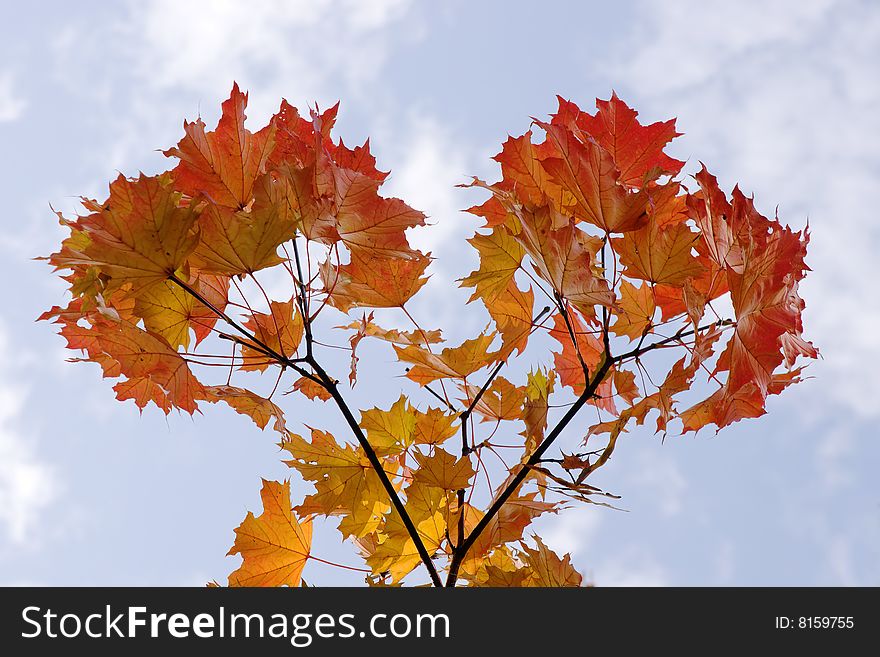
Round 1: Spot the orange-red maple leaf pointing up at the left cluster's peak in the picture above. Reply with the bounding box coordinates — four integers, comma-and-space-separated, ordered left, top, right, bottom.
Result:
164, 84, 275, 210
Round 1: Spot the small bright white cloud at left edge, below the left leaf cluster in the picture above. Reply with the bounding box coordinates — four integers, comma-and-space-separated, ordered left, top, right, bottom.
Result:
0, 327, 56, 543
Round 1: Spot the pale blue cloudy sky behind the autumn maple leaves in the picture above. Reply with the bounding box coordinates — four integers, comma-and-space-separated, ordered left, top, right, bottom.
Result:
0, 0, 880, 586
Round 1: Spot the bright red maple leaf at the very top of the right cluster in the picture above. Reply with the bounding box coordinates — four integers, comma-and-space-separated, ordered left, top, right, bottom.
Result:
553, 93, 684, 187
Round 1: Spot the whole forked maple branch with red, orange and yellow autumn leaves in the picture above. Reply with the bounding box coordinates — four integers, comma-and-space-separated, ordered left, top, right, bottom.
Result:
42, 86, 817, 586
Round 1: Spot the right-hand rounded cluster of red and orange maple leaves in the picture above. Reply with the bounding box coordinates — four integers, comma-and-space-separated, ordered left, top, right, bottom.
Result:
463, 95, 817, 436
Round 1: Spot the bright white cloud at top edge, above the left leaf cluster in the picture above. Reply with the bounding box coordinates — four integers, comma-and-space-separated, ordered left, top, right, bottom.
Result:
125, 0, 418, 114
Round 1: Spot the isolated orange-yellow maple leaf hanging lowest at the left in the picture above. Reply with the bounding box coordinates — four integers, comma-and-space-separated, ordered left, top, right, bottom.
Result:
229, 479, 312, 586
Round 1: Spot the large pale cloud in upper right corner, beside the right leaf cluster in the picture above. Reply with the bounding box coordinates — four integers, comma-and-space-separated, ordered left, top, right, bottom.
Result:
615, 0, 880, 417
